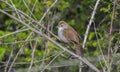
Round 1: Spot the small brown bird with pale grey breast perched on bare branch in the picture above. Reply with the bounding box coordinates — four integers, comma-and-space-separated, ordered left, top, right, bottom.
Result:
58, 21, 83, 57
